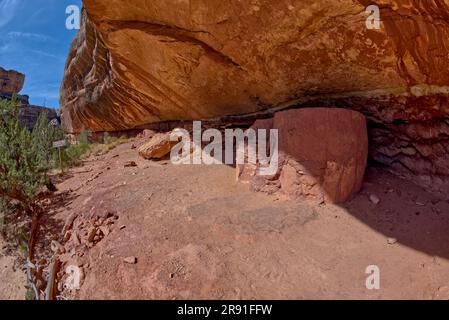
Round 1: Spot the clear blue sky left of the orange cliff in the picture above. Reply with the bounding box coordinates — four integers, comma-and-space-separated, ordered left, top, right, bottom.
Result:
0, 0, 81, 108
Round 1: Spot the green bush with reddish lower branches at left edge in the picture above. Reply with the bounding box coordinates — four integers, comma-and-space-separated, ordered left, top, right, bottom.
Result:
0, 97, 93, 257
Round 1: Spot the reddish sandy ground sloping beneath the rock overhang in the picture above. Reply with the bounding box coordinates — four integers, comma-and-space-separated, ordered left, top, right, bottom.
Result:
2, 138, 449, 299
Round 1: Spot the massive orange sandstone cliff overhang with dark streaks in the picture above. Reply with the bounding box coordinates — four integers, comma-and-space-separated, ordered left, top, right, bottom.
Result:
61, 0, 449, 192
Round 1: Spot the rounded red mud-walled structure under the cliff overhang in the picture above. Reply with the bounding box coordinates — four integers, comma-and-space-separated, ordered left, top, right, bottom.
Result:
237, 108, 368, 203
